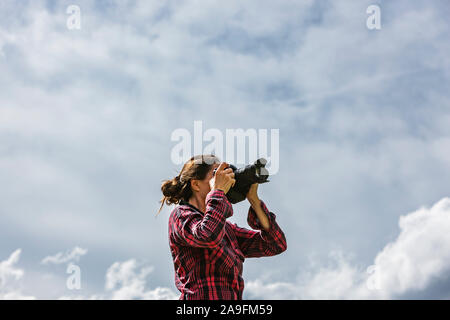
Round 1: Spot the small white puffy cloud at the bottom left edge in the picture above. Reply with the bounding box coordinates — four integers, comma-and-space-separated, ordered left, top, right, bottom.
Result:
0, 249, 35, 300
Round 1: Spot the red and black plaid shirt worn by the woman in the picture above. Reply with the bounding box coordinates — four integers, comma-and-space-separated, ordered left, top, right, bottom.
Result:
169, 190, 287, 300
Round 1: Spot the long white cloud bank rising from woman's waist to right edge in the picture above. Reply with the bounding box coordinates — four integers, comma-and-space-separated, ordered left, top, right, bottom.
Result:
246, 198, 450, 299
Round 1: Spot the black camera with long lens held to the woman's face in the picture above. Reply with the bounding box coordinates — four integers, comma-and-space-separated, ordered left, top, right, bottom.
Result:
213, 158, 269, 204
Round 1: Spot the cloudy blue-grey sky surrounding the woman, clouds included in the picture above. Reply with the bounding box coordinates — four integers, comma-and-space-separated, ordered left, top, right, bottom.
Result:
0, 0, 450, 299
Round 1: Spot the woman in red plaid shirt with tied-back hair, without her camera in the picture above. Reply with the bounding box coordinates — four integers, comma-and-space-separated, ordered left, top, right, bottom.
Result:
159, 155, 287, 300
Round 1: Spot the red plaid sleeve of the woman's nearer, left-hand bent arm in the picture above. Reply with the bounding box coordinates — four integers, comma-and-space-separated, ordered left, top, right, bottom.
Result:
174, 190, 233, 248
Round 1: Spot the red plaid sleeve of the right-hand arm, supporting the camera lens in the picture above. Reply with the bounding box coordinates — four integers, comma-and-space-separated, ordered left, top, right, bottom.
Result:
232, 200, 287, 258
